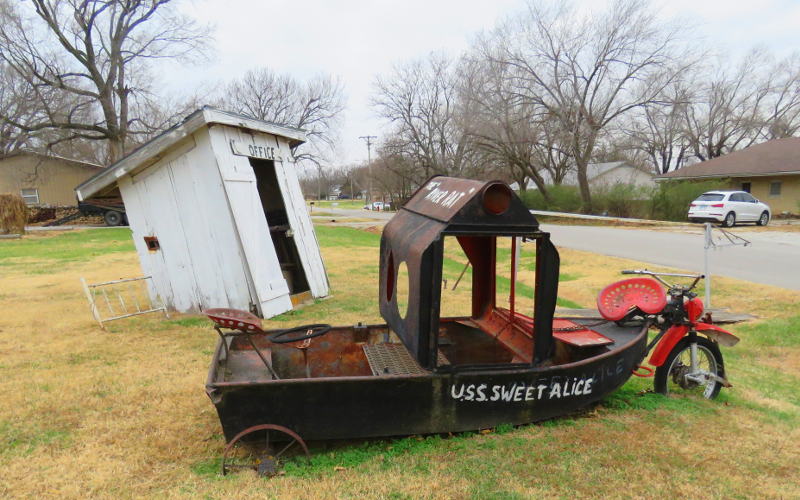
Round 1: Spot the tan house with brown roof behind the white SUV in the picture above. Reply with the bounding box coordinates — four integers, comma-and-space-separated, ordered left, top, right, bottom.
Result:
656, 137, 800, 214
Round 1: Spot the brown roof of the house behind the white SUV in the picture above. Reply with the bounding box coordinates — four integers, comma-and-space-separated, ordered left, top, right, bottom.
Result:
656, 137, 800, 180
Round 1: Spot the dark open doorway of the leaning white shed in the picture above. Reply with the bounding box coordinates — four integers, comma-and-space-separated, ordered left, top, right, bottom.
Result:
250, 158, 311, 298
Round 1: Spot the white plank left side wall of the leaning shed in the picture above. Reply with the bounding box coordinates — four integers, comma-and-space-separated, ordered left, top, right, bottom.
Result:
119, 130, 253, 312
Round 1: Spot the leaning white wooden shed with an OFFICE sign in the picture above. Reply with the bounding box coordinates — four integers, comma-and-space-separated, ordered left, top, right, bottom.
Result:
75, 107, 329, 318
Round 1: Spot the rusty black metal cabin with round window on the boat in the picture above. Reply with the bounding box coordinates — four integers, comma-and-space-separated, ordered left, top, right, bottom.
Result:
380, 177, 559, 370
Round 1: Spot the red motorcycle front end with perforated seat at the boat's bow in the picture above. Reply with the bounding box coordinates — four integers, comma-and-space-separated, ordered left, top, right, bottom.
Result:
597, 269, 739, 399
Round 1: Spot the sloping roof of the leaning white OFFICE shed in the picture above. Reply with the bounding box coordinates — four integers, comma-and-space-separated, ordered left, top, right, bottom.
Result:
75, 106, 306, 201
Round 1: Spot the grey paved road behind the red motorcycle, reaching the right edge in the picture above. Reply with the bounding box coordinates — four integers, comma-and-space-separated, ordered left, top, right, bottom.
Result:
542, 224, 800, 290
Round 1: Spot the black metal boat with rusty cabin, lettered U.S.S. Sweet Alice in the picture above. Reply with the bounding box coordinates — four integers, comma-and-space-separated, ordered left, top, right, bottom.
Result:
206, 177, 648, 472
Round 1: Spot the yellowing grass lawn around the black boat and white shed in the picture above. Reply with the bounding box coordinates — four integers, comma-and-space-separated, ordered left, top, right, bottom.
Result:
0, 226, 800, 499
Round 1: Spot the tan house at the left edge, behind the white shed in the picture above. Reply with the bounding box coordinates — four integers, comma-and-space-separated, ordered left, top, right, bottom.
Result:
0, 151, 103, 207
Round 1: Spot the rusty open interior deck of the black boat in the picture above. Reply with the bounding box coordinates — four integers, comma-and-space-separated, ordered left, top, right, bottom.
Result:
214, 318, 641, 383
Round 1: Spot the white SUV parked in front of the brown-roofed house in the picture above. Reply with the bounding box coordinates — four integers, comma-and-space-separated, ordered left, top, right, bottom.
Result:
689, 191, 772, 227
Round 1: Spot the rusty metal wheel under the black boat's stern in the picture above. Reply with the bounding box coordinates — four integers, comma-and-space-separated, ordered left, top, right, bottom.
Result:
222, 424, 309, 477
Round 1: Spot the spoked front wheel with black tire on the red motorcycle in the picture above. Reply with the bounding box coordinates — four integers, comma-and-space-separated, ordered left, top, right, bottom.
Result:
654, 337, 725, 399
